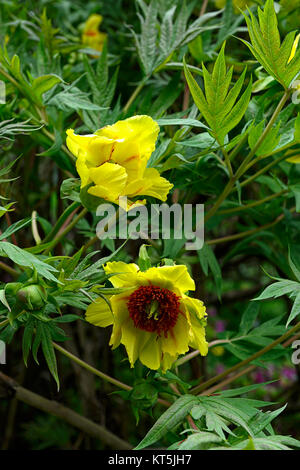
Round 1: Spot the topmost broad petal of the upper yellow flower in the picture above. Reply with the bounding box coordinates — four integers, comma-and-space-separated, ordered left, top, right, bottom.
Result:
96, 115, 159, 160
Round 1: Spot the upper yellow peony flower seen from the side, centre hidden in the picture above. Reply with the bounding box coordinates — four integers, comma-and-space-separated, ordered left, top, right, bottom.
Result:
67, 116, 173, 209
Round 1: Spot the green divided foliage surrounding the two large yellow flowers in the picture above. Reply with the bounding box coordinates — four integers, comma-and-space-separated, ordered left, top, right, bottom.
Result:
0, 0, 300, 450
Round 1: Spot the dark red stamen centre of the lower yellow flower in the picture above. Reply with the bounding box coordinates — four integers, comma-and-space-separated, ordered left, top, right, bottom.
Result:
127, 286, 180, 336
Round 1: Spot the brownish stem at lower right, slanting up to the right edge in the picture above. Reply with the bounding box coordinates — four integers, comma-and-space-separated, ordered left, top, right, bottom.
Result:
190, 322, 300, 395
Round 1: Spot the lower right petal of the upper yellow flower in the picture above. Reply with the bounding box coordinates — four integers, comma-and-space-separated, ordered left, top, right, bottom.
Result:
125, 168, 173, 201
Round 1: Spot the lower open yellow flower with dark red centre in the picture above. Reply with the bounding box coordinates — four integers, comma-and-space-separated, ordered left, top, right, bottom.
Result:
86, 261, 208, 371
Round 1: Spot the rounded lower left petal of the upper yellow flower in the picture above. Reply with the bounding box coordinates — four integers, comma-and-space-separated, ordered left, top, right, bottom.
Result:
88, 162, 127, 202
